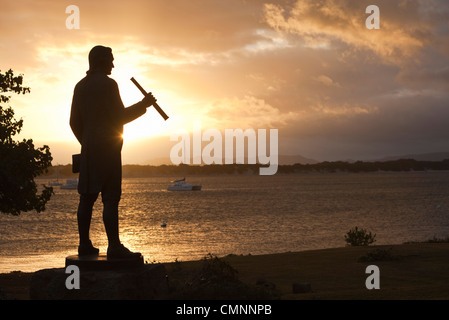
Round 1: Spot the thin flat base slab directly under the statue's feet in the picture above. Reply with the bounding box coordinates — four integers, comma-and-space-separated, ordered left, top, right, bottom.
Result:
65, 254, 144, 270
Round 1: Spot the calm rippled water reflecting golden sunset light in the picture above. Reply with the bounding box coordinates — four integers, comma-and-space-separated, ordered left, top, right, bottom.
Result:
0, 172, 449, 272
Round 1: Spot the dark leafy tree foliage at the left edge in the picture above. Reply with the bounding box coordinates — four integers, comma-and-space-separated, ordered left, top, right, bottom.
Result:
0, 69, 53, 215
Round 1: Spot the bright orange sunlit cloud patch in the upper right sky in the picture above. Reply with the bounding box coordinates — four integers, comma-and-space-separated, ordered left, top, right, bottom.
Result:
265, 0, 429, 63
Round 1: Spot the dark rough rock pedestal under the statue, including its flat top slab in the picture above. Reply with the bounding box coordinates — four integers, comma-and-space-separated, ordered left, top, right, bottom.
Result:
30, 255, 168, 300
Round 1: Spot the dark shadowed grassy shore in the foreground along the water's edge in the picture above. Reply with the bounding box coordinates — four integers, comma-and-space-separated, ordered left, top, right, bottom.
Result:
0, 243, 449, 300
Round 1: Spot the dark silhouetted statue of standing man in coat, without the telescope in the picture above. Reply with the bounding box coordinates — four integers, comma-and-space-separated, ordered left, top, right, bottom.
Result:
70, 46, 156, 258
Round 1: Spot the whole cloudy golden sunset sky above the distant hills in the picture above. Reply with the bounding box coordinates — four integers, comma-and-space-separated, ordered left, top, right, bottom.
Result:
0, 0, 449, 164
